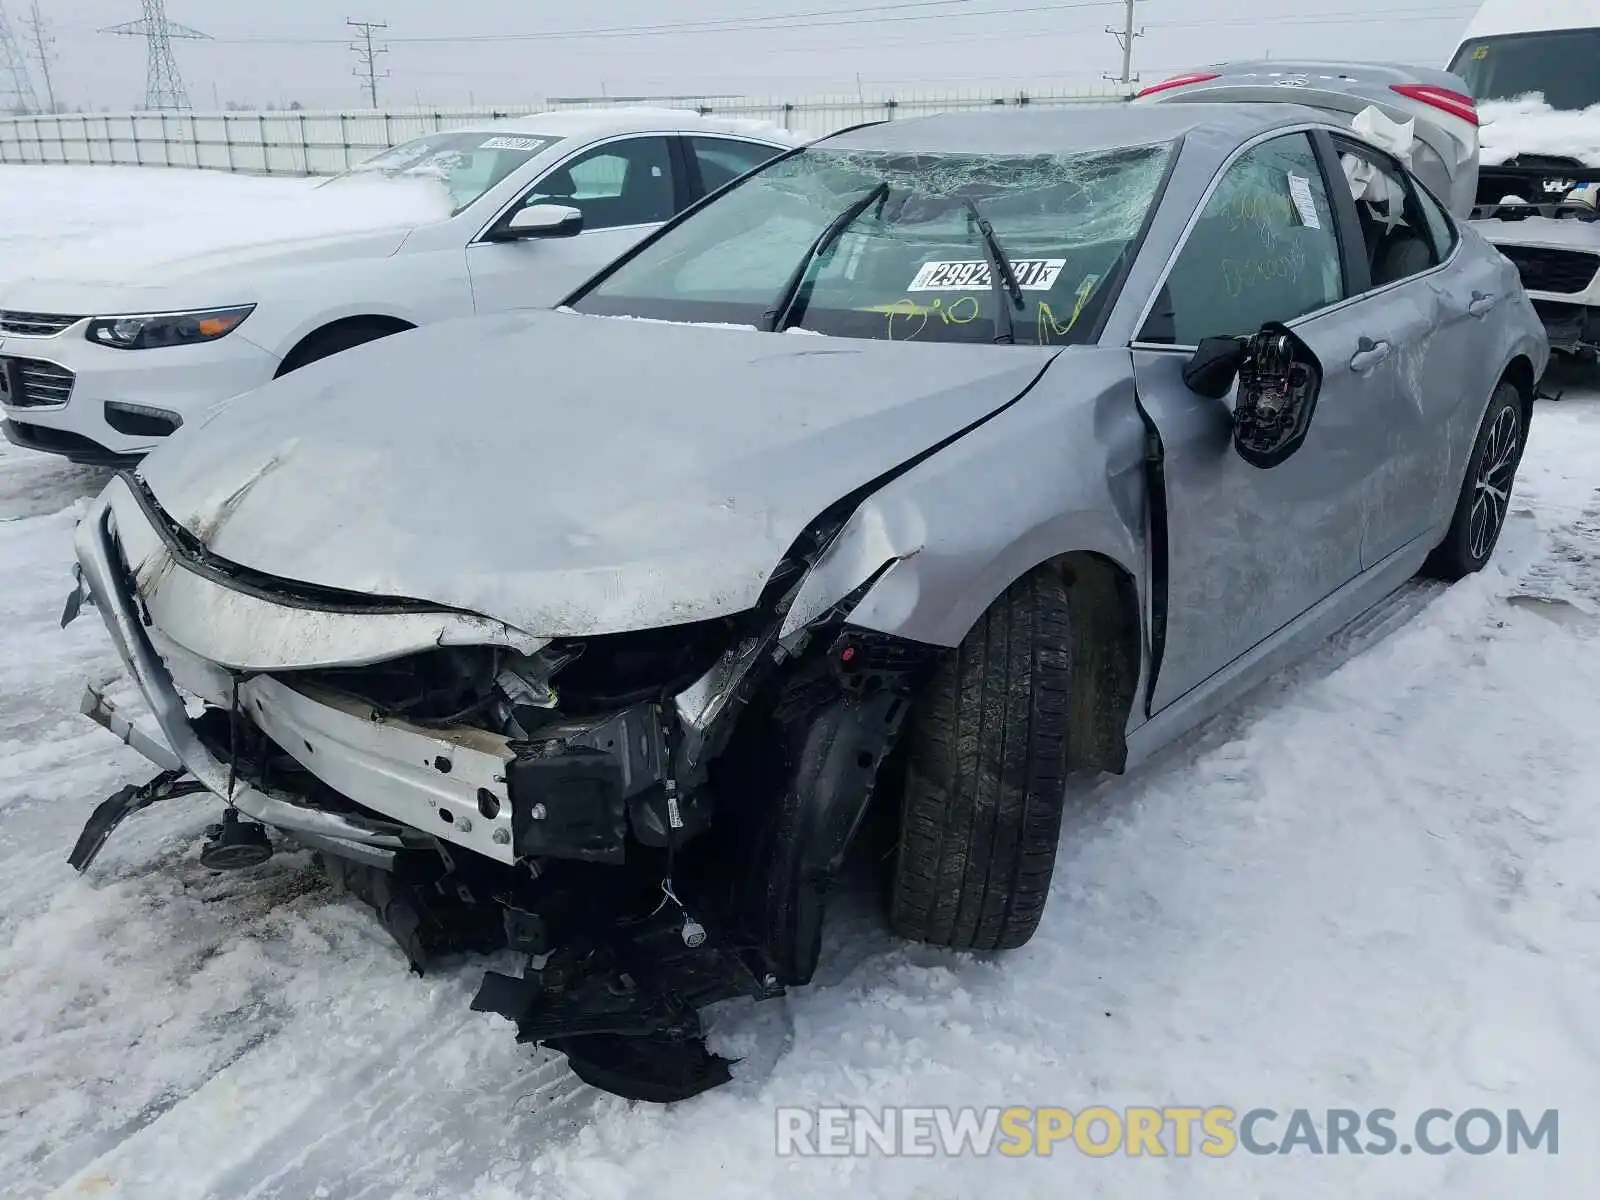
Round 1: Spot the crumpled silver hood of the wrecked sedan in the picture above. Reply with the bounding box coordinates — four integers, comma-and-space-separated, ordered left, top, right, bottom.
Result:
139, 312, 1058, 637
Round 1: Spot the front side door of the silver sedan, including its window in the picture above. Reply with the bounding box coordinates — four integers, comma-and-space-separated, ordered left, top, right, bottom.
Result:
1133, 133, 1387, 715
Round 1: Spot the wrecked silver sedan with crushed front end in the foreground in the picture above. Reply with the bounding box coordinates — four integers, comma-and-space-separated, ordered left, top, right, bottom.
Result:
69, 104, 1549, 1099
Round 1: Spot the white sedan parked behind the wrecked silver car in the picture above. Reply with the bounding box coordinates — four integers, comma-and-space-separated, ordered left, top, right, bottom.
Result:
0, 109, 800, 464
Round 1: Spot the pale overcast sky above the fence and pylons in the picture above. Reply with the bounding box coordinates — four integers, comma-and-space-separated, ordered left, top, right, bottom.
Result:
25, 0, 1475, 109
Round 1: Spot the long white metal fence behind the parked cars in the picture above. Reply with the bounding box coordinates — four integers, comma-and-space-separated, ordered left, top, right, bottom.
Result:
0, 88, 1123, 174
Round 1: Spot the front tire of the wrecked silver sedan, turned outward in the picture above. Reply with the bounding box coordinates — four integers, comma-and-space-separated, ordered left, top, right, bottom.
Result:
890, 568, 1072, 950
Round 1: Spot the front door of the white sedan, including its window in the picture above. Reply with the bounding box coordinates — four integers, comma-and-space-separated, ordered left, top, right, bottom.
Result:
467, 134, 683, 314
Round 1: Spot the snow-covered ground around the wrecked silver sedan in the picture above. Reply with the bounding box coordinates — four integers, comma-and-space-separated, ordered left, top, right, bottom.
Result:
0, 168, 1600, 1200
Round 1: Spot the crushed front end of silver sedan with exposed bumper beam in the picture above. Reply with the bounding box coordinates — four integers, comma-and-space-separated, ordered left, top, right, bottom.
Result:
69, 475, 938, 1101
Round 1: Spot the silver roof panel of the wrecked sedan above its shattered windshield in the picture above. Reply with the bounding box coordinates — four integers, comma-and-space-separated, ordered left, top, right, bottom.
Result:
818, 102, 1328, 154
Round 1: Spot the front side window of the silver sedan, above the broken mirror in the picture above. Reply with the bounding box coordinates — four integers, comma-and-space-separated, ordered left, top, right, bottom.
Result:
1141, 133, 1346, 346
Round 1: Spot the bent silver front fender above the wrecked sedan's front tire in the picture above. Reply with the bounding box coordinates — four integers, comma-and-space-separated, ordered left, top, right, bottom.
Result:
779, 347, 1147, 646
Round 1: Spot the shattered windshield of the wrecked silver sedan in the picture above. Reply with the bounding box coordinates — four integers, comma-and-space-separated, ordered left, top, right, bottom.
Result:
574, 144, 1173, 344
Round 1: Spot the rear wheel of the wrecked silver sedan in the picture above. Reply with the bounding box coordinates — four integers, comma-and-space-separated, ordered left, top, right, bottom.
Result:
1422, 379, 1528, 582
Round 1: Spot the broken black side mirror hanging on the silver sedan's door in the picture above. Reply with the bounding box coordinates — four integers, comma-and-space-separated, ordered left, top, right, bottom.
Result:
1234, 323, 1322, 469
